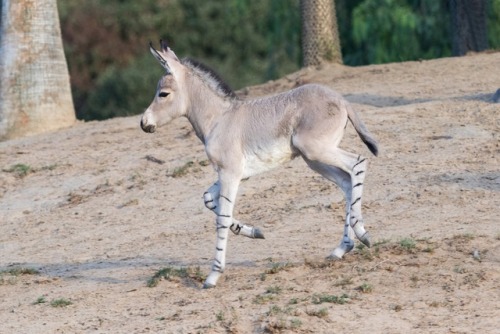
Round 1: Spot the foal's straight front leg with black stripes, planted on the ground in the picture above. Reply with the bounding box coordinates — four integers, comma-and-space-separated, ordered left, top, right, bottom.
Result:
203, 175, 240, 289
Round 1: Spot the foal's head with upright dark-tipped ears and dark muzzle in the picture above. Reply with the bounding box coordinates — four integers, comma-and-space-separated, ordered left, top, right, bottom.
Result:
141, 41, 188, 133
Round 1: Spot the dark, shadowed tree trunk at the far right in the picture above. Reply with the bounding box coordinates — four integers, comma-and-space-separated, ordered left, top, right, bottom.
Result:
450, 0, 488, 56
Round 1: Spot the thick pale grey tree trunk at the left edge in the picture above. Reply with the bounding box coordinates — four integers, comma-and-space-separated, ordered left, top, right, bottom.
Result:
0, 0, 76, 140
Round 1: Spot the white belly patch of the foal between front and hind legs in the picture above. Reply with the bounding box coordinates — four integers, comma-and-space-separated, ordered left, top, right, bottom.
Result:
242, 141, 297, 179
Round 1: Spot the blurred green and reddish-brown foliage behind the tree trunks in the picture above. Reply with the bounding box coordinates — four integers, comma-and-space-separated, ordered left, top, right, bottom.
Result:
58, 0, 500, 120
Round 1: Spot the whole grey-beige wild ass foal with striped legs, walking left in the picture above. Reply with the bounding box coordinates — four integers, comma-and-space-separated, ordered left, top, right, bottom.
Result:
141, 42, 378, 288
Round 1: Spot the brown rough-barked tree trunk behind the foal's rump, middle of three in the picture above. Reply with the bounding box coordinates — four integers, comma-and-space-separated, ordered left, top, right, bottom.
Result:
300, 0, 342, 66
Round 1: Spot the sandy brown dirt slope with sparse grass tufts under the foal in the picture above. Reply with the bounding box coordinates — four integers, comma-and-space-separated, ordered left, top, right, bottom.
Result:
0, 53, 500, 333
